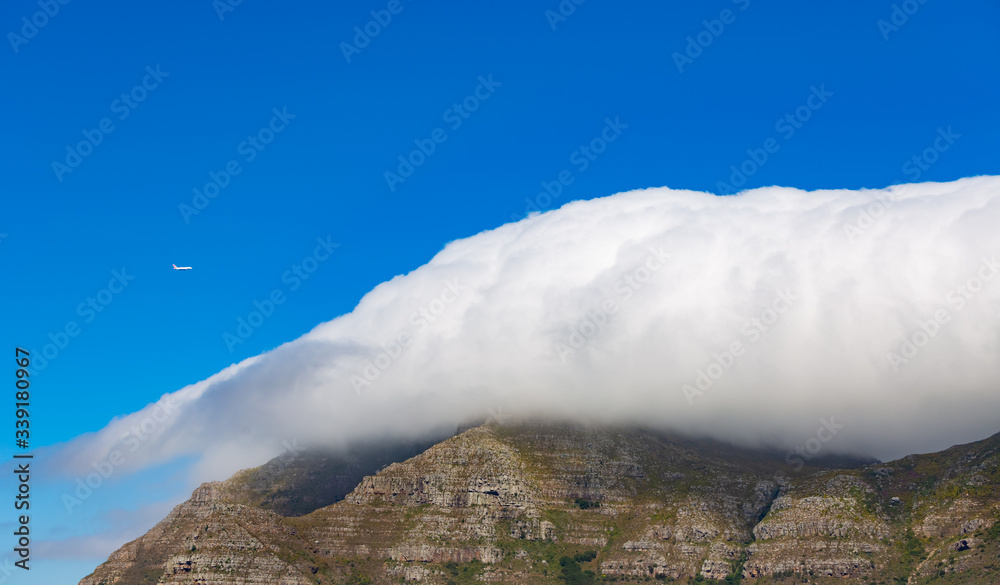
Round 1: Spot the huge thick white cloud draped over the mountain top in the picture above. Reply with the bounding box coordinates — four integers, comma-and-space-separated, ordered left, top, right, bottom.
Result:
47, 177, 1000, 478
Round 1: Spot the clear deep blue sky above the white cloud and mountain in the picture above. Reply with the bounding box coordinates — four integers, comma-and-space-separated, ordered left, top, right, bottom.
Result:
0, 0, 1000, 582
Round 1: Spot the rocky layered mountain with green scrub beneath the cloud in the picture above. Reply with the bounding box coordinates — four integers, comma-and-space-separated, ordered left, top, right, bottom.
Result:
81, 423, 1000, 585
